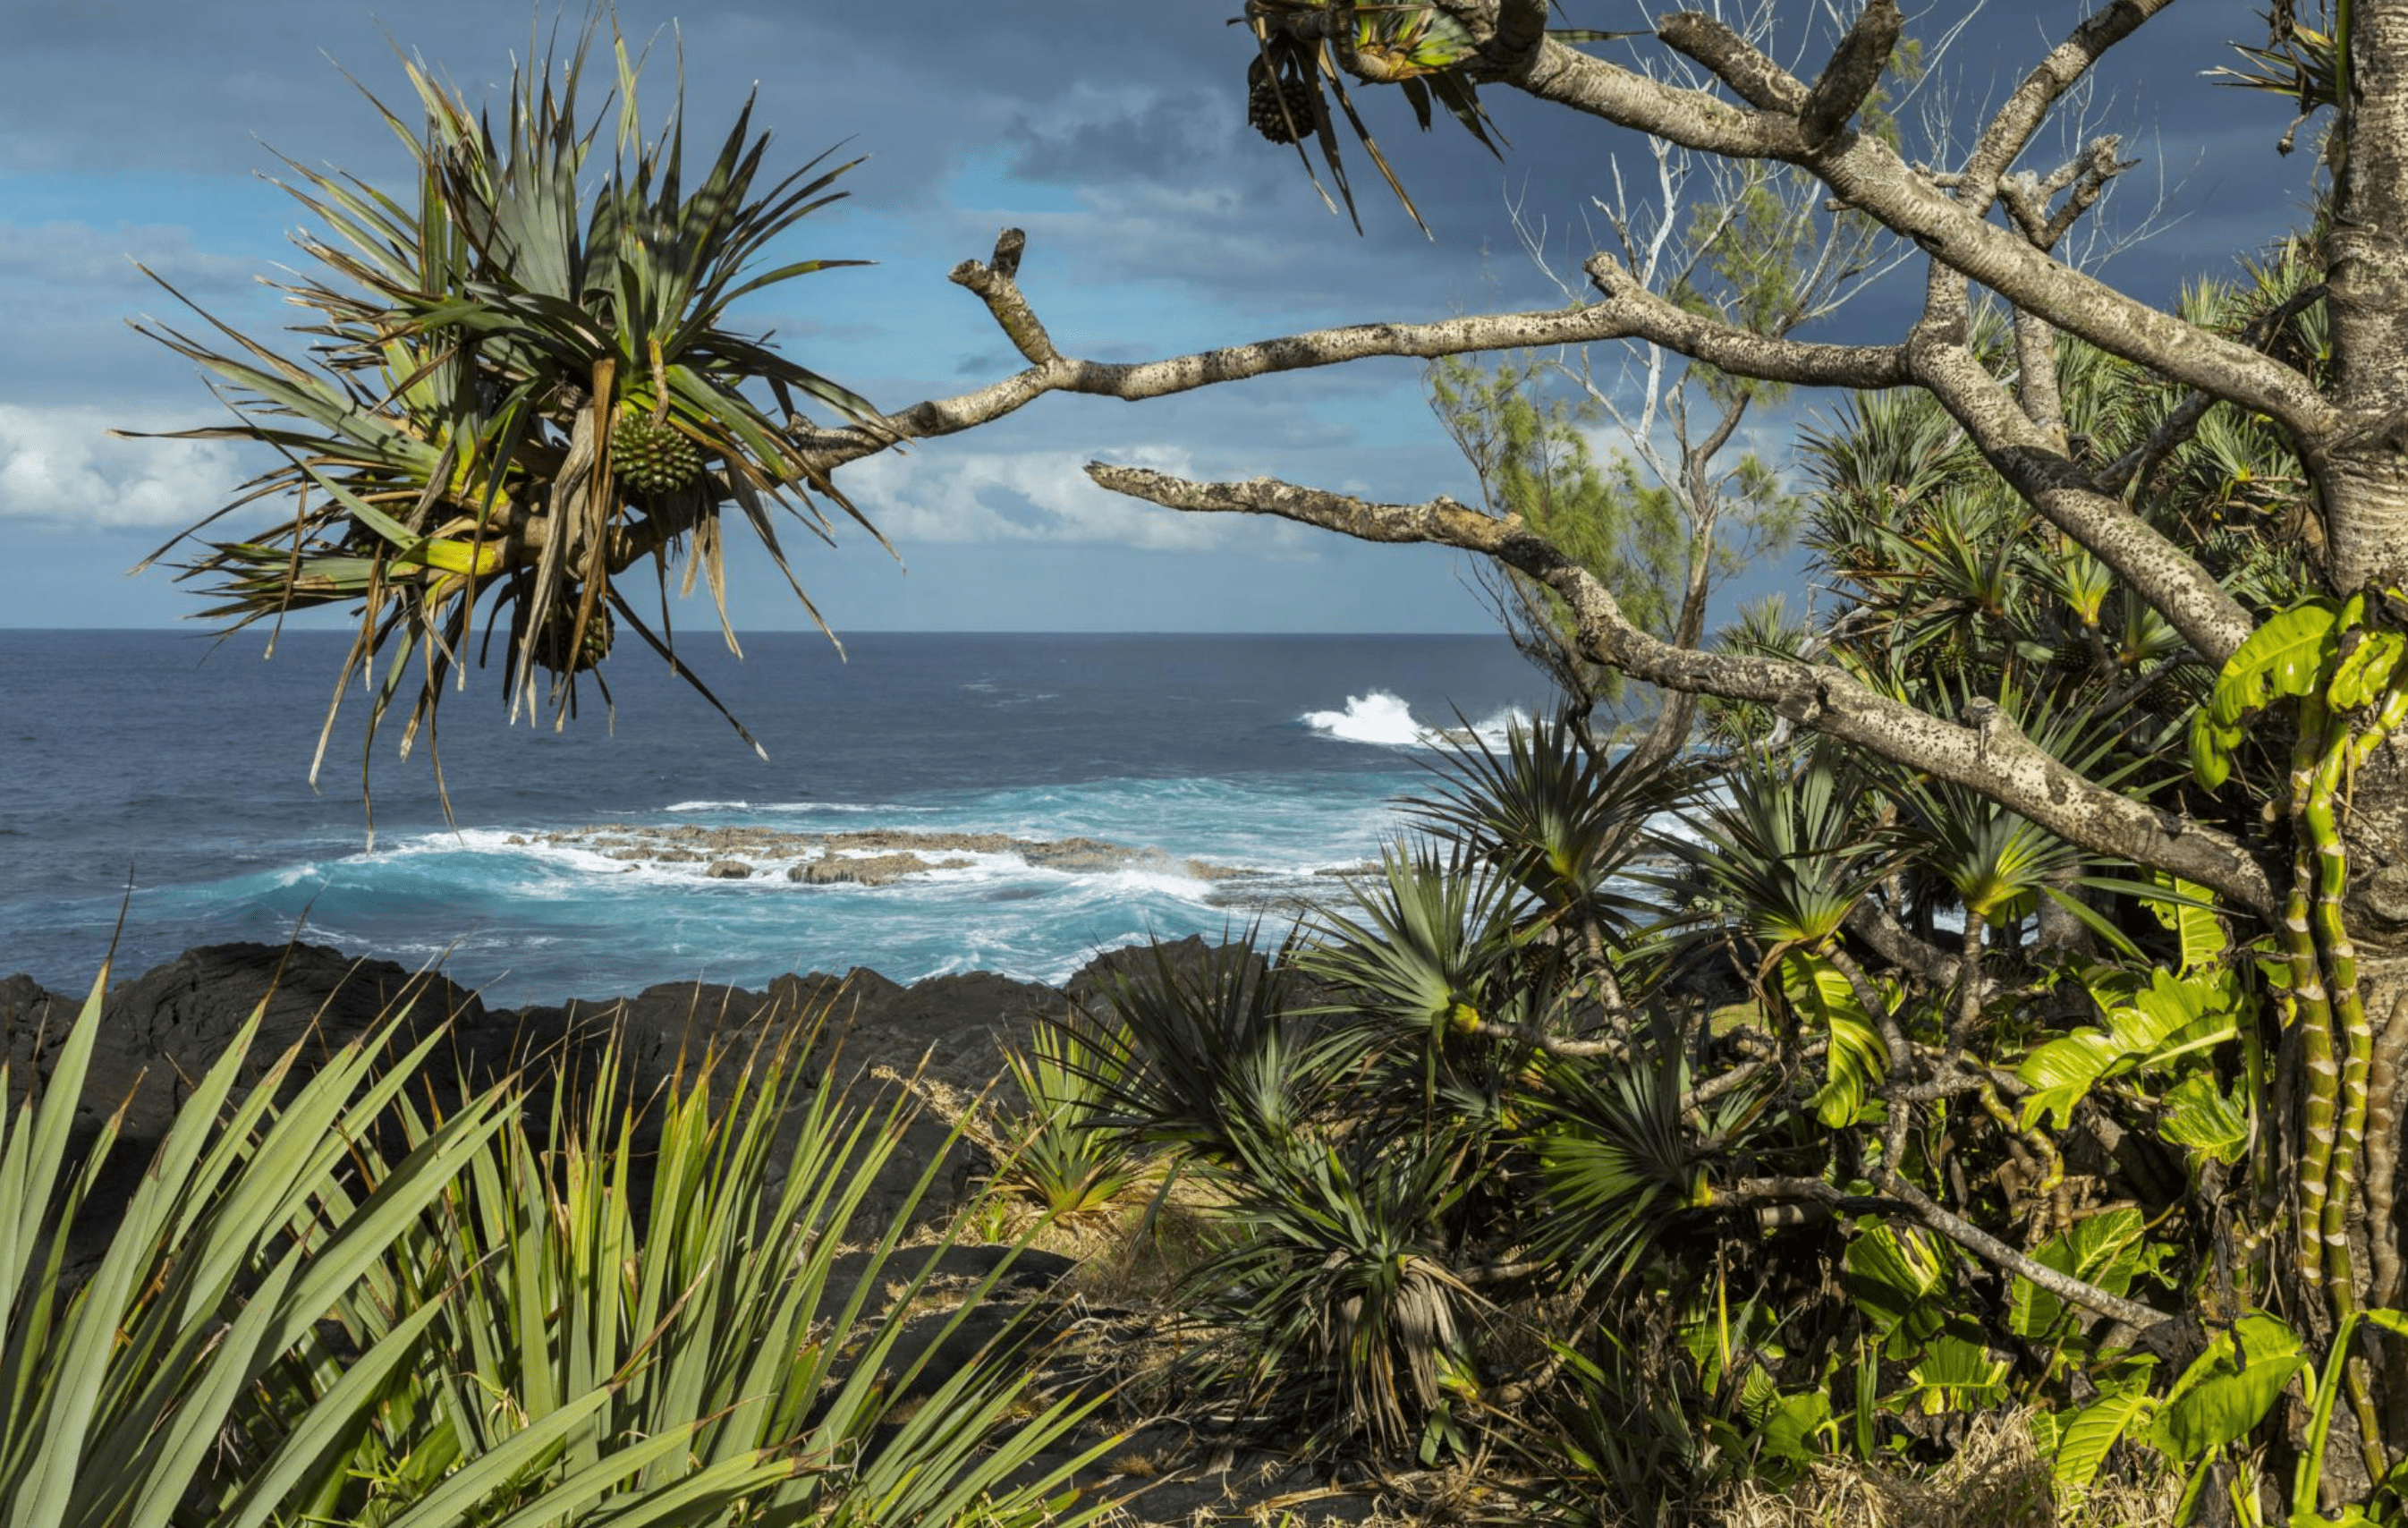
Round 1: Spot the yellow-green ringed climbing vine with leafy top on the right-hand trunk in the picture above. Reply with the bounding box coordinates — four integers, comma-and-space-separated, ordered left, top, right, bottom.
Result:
2192, 595, 2408, 1470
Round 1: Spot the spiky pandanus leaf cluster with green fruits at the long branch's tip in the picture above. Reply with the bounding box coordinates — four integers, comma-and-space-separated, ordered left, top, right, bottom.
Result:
142, 27, 877, 828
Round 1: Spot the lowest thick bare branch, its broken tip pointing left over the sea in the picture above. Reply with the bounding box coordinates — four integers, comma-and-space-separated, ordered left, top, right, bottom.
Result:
1086, 463, 2280, 918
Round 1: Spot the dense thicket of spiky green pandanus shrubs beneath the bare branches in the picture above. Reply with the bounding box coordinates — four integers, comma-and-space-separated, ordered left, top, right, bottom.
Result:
1021, 243, 2408, 1528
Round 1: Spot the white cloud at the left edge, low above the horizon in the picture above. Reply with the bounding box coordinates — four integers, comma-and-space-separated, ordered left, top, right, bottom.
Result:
0, 403, 248, 528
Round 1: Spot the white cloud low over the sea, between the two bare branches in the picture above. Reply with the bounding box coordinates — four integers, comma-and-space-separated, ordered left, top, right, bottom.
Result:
843, 441, 1305, 555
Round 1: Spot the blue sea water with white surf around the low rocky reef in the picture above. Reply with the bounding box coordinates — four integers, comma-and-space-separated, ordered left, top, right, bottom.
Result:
0, 632, 1546, 1003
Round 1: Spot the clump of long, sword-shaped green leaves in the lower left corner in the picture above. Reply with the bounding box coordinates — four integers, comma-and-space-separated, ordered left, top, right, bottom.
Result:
0, 963, 1106, 1528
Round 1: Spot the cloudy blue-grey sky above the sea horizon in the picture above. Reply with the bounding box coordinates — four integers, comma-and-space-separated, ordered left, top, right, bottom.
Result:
0, 0, 2310, 632
